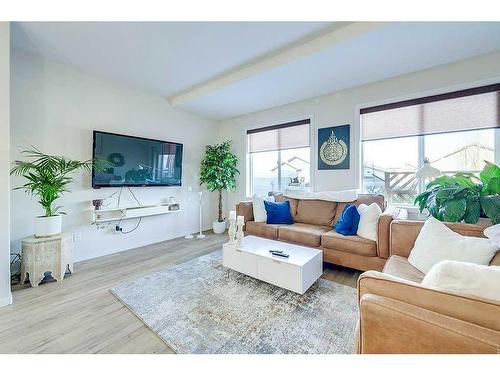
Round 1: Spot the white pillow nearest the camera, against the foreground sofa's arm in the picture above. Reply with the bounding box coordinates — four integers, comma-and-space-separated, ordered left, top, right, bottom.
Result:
422, 260, 500, 300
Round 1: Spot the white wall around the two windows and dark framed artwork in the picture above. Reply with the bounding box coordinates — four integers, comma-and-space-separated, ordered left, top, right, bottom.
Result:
219, 52, 500, 214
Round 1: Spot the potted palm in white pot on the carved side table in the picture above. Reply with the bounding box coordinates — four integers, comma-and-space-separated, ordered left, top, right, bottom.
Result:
10, 147, 99, 237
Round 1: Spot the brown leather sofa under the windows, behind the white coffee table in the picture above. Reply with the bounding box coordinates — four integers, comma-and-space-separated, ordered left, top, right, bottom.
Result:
236, 194, 406, 271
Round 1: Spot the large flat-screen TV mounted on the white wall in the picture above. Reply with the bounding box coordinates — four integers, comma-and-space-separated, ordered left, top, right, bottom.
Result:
92, 131, 182, 188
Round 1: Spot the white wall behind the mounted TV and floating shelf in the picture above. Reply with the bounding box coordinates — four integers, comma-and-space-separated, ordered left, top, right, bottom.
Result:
10, 50, 217, 264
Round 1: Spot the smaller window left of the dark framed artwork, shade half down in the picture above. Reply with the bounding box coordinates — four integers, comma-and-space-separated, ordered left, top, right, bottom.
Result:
247, 120, 311, 196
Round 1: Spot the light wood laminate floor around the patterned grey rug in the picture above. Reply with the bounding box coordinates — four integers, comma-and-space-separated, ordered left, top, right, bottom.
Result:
0, 233, 360, 353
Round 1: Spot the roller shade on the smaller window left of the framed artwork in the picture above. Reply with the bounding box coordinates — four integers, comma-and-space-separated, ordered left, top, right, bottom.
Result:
247, 120, 310, 153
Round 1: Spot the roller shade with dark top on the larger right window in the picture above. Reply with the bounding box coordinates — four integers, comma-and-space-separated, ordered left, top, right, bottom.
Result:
361, 84, 500, 141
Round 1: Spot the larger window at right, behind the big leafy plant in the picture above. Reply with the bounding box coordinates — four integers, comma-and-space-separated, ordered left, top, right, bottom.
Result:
360, 84, 500, 204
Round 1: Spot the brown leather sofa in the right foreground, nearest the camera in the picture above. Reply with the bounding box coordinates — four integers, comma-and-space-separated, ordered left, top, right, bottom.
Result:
357, 220, 500, 353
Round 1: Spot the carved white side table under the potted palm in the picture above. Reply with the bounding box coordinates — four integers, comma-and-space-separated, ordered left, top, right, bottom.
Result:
21, 233, 73, 287
